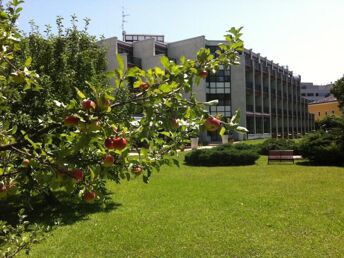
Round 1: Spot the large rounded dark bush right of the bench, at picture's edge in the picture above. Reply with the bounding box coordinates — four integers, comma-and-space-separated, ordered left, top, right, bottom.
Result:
299, 131, 344, 165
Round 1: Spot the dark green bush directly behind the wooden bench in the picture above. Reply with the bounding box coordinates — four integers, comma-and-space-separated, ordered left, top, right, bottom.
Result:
258, 138, 299, 155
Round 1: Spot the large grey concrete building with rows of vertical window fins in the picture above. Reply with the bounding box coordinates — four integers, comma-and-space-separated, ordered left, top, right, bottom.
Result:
99, 35, 314, 140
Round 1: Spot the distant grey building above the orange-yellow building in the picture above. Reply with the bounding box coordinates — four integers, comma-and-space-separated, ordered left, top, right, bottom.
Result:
301, 82, 332, 101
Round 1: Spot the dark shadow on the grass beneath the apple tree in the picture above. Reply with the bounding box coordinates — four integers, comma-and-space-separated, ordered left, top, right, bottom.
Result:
0, 190, 121, 226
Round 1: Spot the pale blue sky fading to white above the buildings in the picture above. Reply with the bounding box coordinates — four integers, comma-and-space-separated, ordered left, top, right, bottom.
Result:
13, 0, 344, 84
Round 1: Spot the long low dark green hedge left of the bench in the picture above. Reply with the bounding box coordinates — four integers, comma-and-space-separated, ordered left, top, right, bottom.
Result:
185, 144, 259, 166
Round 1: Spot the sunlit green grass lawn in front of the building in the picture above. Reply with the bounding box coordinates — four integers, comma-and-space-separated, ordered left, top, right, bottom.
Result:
22, 154, 344, 257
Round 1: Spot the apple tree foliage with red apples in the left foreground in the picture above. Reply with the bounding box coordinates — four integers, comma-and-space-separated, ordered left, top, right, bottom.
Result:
0, 0, 243, 207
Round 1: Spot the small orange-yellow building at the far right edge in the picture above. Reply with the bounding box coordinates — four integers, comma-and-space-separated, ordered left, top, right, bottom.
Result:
308, 95, 342, 121
